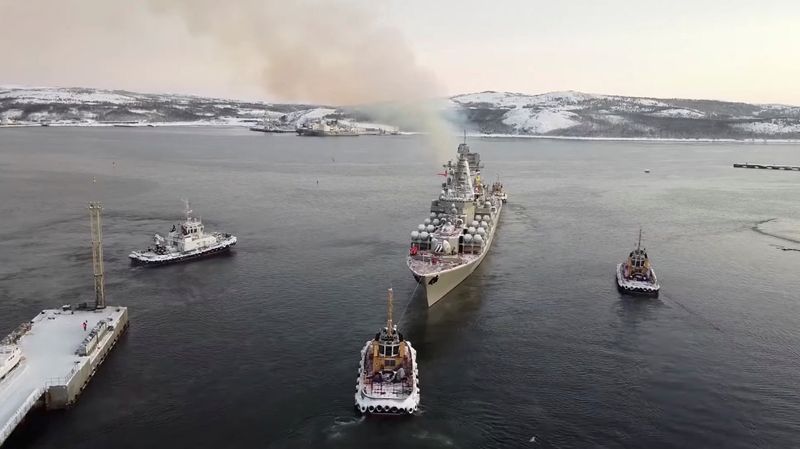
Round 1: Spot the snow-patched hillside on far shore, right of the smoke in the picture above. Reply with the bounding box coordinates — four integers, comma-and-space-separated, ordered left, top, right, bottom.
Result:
448, 91, 800, 139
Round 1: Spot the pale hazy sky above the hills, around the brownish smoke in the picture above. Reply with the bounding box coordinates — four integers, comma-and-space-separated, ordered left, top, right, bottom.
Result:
0, 0, 800, 105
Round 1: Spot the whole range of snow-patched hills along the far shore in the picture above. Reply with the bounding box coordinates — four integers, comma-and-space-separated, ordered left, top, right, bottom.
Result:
0, 87, 800, 139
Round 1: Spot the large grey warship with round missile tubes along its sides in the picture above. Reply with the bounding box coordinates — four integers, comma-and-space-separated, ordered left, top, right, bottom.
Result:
407, 137, 506, 307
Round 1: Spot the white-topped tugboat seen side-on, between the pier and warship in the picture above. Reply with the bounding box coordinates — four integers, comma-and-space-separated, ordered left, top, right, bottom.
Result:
128, 200, 237, 265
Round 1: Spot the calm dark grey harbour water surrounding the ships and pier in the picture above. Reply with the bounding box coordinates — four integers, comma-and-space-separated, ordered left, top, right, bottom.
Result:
0, 128, 800, 449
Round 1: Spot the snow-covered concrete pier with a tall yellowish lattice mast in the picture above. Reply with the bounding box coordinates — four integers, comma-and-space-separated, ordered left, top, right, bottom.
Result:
0, 203, 128, 445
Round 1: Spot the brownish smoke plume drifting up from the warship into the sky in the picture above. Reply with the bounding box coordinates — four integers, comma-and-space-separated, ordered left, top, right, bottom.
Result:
146, 0, 454, 158
